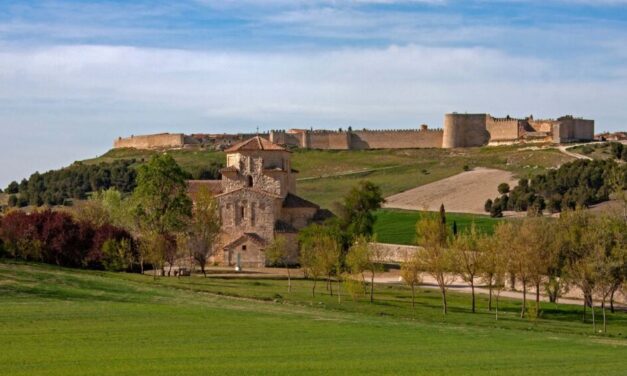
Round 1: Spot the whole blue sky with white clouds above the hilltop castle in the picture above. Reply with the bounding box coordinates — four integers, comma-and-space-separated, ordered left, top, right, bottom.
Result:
0, 0, 627, 187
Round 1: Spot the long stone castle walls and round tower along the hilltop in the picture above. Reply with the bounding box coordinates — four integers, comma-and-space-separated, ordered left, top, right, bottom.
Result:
114, 113, 594, 150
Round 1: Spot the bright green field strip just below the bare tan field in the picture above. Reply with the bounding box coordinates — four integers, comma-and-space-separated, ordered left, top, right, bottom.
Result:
374, 209, 503, 245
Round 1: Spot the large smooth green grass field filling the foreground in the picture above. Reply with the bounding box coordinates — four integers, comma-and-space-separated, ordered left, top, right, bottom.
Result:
0, 262, 627, 375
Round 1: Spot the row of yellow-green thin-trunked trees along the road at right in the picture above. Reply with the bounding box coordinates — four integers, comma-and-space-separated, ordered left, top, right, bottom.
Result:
408, 209, 627, 331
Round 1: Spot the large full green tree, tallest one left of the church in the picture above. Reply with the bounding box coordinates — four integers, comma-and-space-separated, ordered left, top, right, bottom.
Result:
132, 154, 192, 275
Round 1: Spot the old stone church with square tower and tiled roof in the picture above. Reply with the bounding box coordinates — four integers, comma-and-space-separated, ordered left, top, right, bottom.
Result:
188, 136, 329, 267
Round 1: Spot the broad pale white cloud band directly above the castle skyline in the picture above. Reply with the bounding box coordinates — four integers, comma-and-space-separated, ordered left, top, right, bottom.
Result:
0, 45, 627, 185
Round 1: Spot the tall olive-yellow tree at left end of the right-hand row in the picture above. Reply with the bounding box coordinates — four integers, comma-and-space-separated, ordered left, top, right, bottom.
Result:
416, 215, 454, 314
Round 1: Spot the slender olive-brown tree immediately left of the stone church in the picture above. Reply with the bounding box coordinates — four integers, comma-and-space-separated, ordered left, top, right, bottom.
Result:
184, 187, 222, 277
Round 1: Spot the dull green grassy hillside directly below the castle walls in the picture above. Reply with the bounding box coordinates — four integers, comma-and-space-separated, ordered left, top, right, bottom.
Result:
84, 146, 572, 209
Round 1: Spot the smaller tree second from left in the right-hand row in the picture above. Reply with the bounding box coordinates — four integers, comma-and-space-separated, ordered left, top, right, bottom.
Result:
451, 223, 481, 313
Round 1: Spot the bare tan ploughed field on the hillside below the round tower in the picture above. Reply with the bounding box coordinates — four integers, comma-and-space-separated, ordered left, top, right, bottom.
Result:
384, 167, 516, 214
